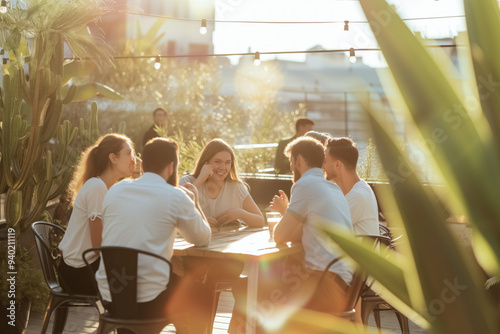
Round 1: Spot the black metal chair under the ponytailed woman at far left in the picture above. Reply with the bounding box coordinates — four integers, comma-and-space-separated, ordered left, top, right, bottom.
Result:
31, 222, 98, 334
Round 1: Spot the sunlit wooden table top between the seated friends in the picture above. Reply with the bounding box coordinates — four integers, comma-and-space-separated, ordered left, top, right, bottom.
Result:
174, 226, 302, 261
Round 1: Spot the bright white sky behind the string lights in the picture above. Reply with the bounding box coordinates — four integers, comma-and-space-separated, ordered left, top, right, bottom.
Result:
213, 0, 465, 67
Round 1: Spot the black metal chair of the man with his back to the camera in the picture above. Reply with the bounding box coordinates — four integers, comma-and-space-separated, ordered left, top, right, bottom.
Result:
82, 246, 172, 334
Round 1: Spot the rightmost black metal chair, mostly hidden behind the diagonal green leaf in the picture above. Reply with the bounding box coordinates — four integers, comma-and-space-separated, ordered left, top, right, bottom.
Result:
361, 225, 410, 334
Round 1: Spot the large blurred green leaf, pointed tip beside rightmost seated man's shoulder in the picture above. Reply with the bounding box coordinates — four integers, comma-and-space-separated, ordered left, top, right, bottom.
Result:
368, 107, 499, 333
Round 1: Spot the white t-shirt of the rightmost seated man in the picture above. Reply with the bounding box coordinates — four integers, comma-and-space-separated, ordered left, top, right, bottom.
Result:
345, 180, 379, 235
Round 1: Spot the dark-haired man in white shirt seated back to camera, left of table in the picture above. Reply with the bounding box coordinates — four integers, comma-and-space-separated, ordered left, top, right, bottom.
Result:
96, 138, 211, 333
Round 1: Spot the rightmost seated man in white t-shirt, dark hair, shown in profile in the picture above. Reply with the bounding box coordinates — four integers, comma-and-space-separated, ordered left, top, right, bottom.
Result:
323, 137, 379, 235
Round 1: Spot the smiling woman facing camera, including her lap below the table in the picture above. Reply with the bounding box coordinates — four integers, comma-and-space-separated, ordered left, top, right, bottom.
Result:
179, 139, 264, 287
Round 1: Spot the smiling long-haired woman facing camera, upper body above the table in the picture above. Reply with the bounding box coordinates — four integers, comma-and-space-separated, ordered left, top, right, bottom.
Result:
179, 139, 264, 227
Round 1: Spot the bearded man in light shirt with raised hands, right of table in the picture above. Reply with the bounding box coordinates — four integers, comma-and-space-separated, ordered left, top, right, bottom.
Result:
271, 137, 352, 313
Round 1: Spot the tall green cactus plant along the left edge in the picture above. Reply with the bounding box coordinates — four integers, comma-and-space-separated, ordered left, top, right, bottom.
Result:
0, 0, 111, 231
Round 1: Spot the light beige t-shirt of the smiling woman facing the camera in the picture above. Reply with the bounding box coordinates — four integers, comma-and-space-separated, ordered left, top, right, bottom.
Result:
179, 175, 250, 218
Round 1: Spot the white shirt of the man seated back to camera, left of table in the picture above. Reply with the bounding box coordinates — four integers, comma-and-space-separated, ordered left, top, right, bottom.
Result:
96, 173, 212, 303
